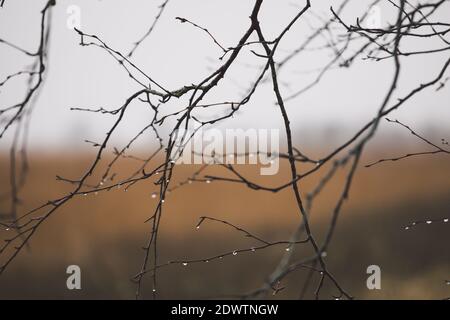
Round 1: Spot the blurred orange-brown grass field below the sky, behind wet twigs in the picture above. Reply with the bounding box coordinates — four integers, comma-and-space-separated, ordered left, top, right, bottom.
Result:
0, 154, 450, 299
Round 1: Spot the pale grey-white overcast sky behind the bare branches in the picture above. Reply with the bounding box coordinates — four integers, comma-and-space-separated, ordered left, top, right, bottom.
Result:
0, 0, 450, 149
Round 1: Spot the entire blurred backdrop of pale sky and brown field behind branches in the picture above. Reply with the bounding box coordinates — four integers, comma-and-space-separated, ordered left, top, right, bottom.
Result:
0, 0, 450, 299
